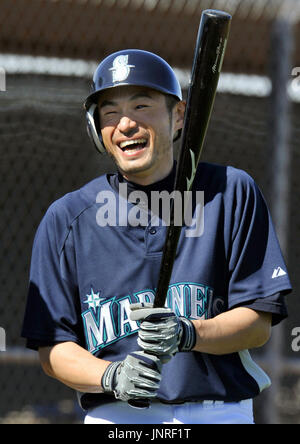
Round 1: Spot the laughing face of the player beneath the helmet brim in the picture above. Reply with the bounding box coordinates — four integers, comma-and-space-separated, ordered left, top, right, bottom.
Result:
98, 86, 184, 186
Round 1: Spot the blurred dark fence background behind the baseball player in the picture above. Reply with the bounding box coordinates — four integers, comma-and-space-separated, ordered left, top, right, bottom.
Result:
0, 0, 300, 424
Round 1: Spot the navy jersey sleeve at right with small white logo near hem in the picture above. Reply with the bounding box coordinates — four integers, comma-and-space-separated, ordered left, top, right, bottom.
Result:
228, 173, 291, 308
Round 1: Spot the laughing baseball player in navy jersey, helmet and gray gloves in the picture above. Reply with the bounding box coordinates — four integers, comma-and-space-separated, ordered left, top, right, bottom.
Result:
22, 50, 291, 424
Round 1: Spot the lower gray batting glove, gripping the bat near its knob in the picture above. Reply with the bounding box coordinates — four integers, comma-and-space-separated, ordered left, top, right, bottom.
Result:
101, 351, 162, 401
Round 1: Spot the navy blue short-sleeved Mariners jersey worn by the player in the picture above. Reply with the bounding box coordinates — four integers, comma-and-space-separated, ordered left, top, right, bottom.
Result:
22, 163, 291, 407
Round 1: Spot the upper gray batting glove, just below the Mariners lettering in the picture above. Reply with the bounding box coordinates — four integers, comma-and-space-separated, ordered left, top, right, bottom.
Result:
130, 304, 196, 364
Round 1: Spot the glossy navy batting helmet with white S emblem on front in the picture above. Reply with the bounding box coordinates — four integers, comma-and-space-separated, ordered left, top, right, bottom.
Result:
84, 49, 182, 153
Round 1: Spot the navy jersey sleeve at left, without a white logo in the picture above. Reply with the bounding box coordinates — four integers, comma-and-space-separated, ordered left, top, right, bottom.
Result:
22, 207, 81, 349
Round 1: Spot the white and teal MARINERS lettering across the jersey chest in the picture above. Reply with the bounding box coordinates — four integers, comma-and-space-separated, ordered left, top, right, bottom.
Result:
82, 282, 213, 353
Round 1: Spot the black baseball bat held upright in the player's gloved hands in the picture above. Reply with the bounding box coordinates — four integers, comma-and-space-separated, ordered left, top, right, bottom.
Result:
128, 9, 232, 408
